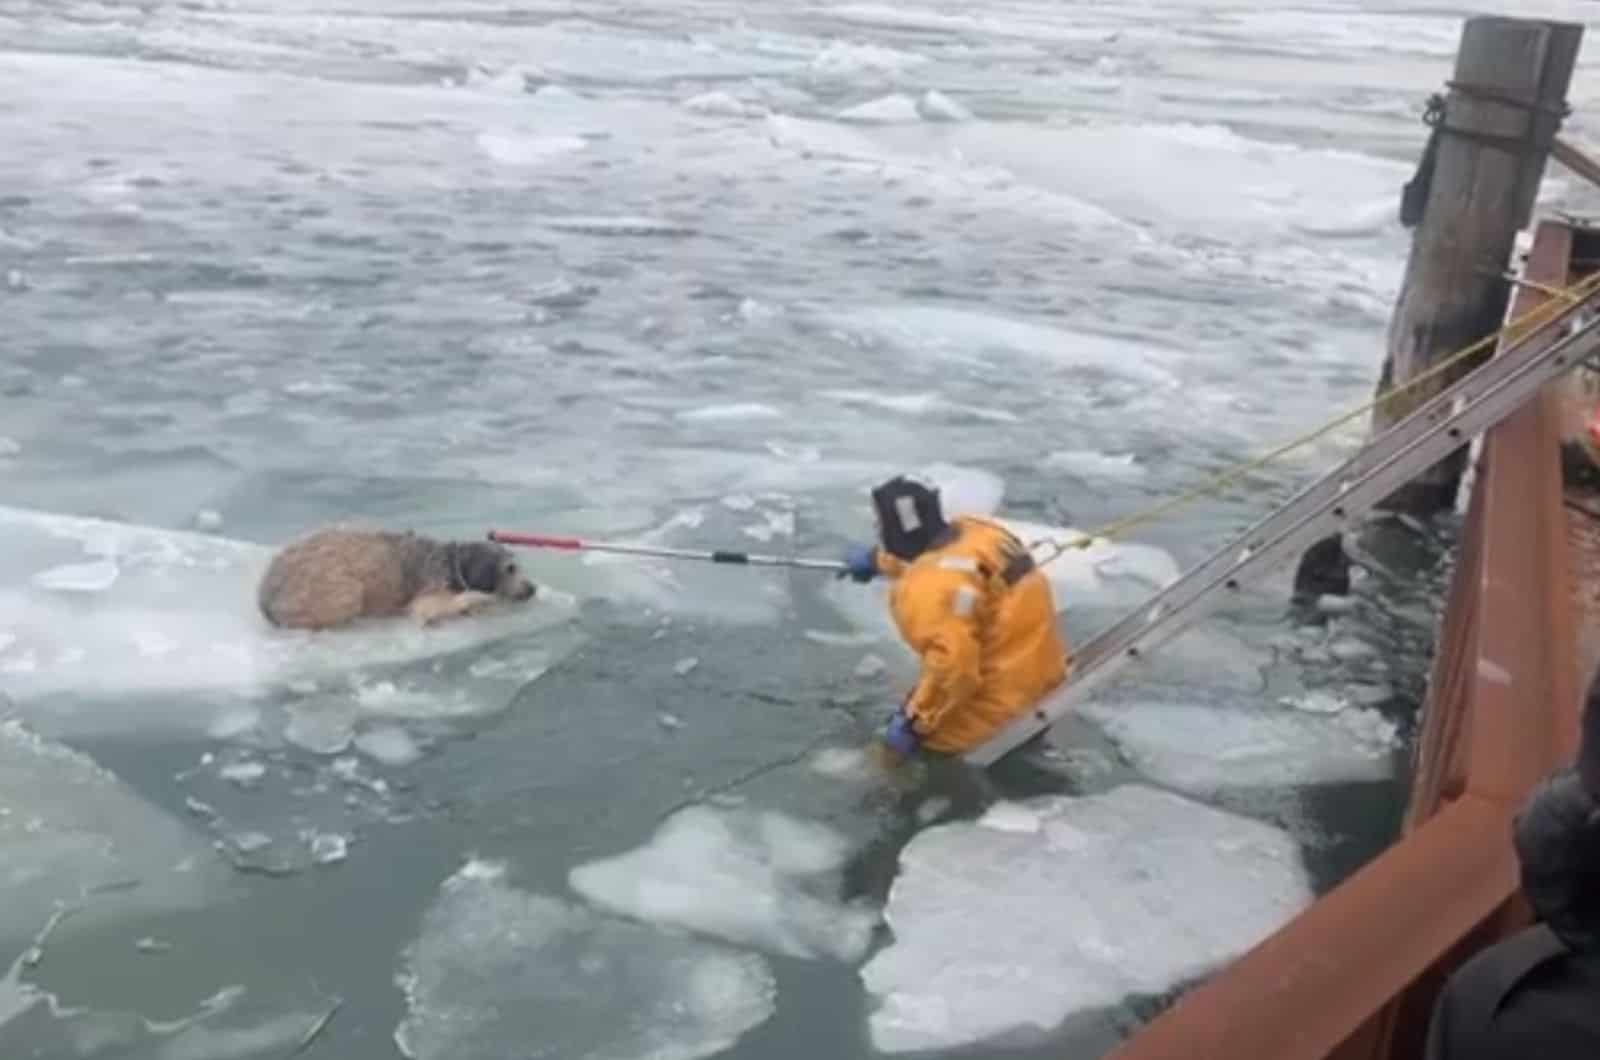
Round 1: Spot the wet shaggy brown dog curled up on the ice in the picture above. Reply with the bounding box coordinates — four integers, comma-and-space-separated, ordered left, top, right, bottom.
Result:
256, 527, 538, 629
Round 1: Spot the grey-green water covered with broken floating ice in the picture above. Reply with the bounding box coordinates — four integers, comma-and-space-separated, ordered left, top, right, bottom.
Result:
9, 0, 1595, 1060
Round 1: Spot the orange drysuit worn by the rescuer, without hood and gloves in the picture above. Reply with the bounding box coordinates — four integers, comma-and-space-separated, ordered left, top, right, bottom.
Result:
877, 516, 1070, 754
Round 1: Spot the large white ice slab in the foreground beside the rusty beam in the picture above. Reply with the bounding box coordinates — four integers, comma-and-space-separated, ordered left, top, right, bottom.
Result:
861, 786, 1310, 1052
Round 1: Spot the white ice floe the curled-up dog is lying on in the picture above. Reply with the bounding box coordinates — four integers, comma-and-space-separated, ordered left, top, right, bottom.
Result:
0, 506, 573, 733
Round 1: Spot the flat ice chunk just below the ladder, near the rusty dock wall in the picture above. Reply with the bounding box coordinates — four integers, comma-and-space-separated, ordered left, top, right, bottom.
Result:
1083, 701, 1395, 796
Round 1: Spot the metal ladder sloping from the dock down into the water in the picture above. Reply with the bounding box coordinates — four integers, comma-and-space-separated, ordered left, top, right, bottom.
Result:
965, 291, 1600, 767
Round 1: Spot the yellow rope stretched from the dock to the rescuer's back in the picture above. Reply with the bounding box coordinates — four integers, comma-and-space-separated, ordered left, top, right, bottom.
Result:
1032, 272, 1600, 567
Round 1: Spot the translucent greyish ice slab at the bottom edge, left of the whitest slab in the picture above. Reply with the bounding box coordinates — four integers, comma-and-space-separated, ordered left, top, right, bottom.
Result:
395, 861, 776, 1060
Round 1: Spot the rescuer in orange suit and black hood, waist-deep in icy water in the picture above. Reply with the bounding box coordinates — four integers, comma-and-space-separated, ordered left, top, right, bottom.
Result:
845, 476, 1070, 759
